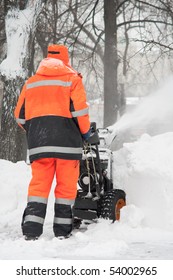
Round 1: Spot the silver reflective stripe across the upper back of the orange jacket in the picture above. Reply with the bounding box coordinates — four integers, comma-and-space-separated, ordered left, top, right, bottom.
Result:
26, 80, 72, 89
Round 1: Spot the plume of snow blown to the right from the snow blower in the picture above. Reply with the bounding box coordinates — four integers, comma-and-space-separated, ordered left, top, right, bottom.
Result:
107, 77, 173, 146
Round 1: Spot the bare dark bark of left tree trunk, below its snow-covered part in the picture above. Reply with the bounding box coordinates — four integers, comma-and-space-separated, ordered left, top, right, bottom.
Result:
0, 77, 26, 162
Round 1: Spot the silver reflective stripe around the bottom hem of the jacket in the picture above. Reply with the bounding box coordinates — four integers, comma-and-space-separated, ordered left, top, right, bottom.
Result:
29, 146, 82, 156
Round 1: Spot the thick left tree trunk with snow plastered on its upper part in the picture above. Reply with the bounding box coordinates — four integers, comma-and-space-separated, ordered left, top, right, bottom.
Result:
0, 0, 42, 162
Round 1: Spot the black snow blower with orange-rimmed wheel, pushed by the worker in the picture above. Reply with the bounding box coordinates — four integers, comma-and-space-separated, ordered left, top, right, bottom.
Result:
74, 122, 126, 228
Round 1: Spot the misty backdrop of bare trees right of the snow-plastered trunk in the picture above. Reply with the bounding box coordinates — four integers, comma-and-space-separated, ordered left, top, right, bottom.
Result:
34, 0, 173, 126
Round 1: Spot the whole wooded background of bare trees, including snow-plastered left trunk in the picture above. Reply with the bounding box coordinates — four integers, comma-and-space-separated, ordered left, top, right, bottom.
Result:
0, 0, 173, 161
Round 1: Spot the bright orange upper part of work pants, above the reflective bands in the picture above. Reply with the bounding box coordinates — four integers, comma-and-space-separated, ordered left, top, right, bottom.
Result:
28, 158, 79, 199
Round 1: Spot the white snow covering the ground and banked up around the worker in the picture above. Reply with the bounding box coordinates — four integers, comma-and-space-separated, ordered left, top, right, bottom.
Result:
0, 132, 173, 260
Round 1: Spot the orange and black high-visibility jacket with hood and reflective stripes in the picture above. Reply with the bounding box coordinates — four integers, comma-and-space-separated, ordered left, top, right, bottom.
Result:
15, 58, 90, 162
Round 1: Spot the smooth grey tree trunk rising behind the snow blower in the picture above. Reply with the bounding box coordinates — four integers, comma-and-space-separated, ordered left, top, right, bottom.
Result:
104, 0, 119, 127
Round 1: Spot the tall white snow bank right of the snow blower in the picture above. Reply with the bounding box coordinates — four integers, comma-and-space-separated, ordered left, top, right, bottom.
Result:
113, 132, 173, 230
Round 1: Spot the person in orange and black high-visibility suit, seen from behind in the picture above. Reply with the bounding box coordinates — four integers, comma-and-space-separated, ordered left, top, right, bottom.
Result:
15, 45, 90, 240
